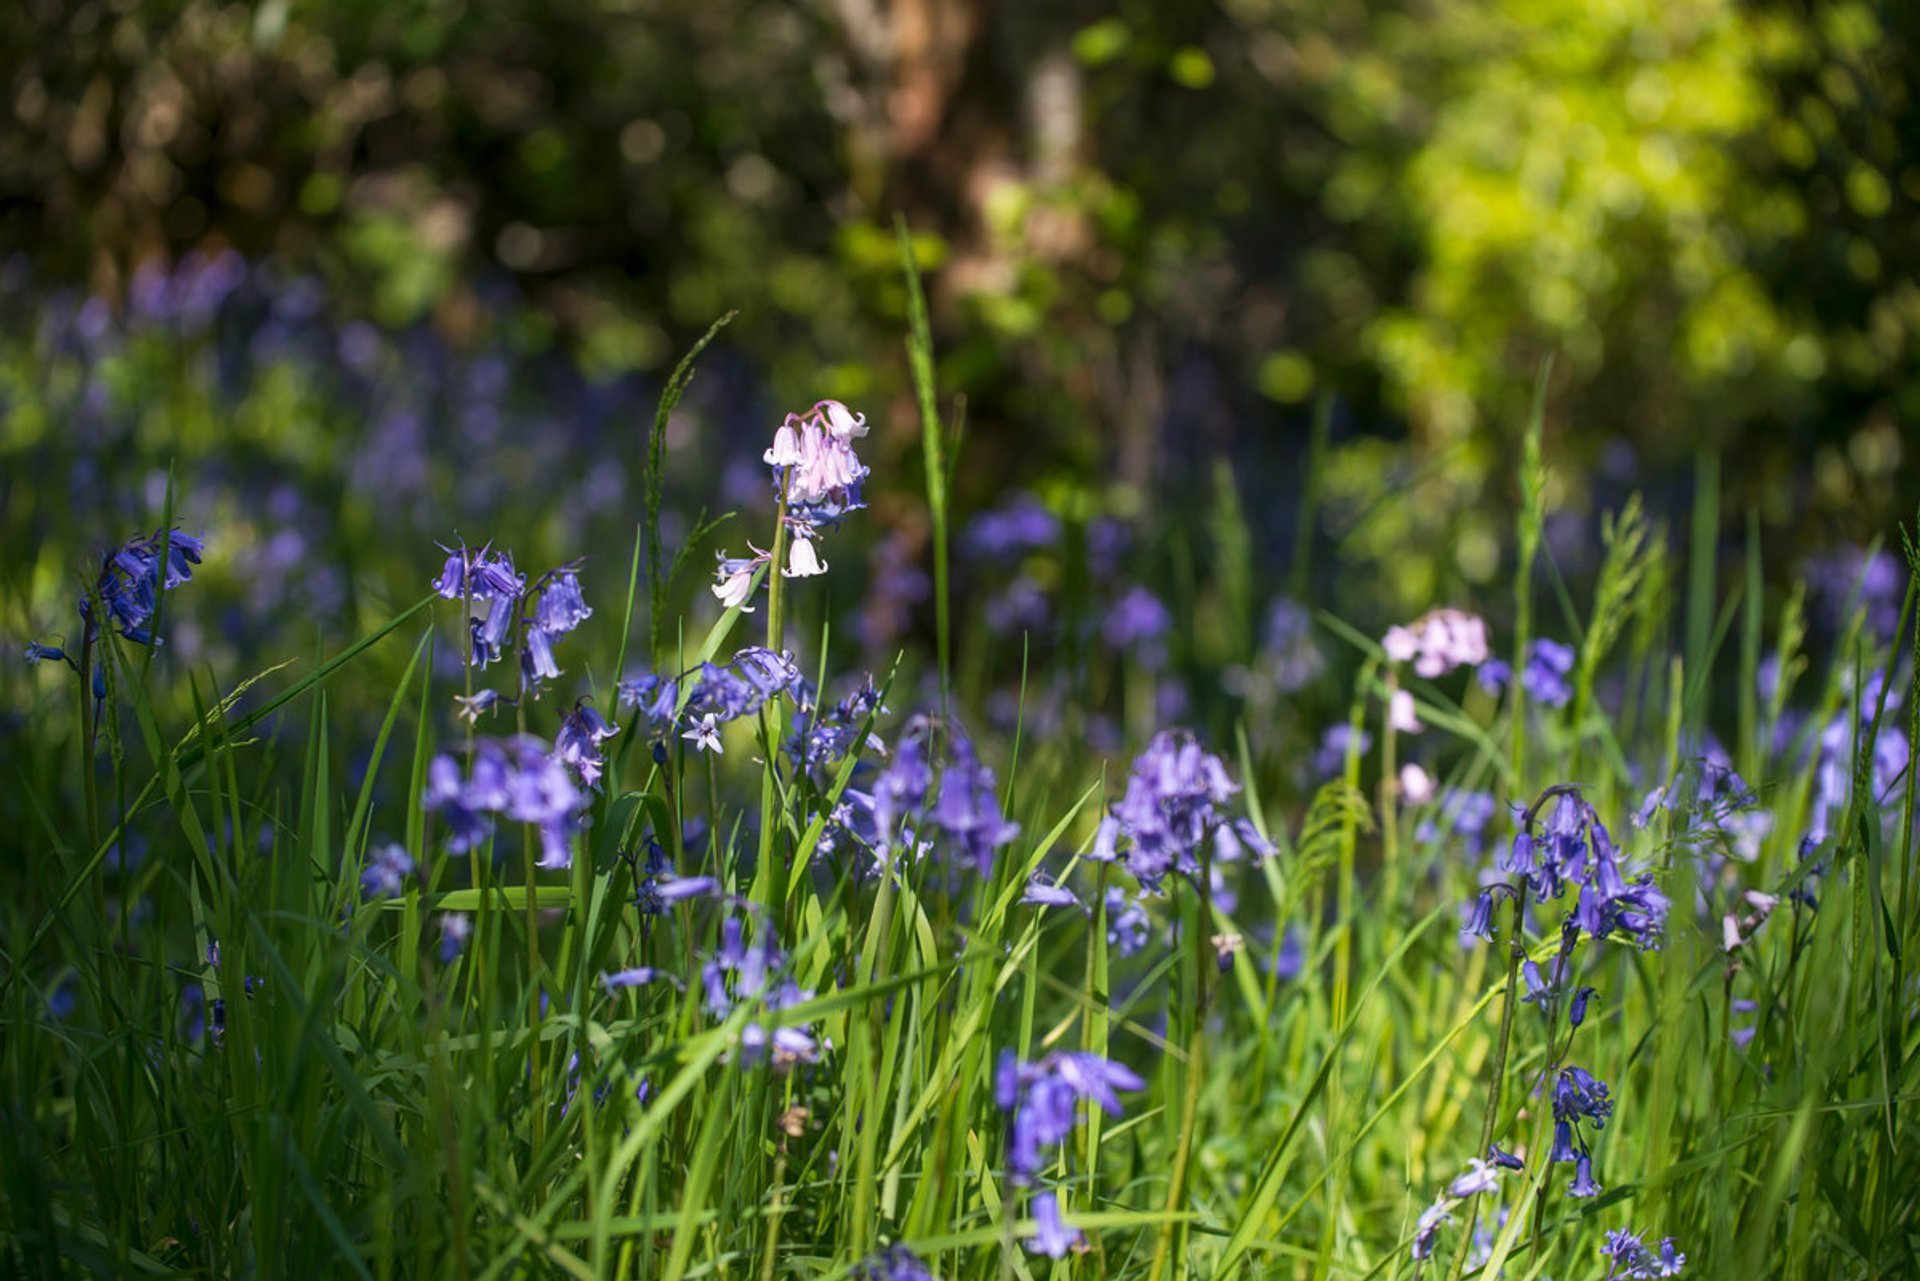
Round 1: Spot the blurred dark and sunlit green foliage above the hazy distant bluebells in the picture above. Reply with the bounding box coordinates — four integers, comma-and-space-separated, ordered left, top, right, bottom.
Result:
0, 0, 1920, 599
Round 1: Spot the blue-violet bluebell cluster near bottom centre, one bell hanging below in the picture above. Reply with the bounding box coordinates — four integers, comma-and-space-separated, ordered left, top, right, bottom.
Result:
993, 1051, 1146, 1258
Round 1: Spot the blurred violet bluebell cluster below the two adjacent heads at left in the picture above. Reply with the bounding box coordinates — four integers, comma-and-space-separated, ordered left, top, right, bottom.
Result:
422, 734, 588, 868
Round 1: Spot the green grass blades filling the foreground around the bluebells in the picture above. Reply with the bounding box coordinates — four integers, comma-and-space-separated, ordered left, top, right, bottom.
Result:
0, 334, 1920, 1281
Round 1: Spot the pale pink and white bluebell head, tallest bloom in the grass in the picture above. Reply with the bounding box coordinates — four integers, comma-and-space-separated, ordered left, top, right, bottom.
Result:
712, 399, 868, 611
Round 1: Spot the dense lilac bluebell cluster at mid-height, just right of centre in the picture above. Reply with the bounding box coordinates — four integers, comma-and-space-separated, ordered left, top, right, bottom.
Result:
1087, 730, 1273, 893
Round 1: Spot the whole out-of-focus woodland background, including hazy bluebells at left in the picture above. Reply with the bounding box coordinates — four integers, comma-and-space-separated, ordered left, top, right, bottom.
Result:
0, 0, 1920, 676
